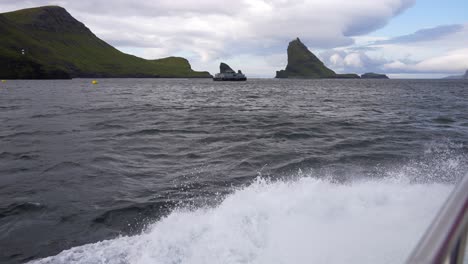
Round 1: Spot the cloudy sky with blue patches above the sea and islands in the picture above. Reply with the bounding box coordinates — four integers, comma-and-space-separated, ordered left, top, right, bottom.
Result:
0, 0, 468, 78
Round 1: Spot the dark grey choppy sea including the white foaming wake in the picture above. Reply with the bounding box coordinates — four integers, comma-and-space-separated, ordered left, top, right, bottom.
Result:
0, 79, 468, 264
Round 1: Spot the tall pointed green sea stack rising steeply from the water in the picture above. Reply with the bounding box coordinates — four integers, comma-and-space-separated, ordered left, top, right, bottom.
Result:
276, 38, 336, 79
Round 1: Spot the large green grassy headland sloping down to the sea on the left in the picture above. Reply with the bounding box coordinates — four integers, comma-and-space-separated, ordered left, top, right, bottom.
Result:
0, 6, 212, 79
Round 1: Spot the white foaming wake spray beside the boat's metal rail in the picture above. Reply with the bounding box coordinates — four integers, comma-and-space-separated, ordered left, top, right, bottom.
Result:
33, 178, 453, 264
